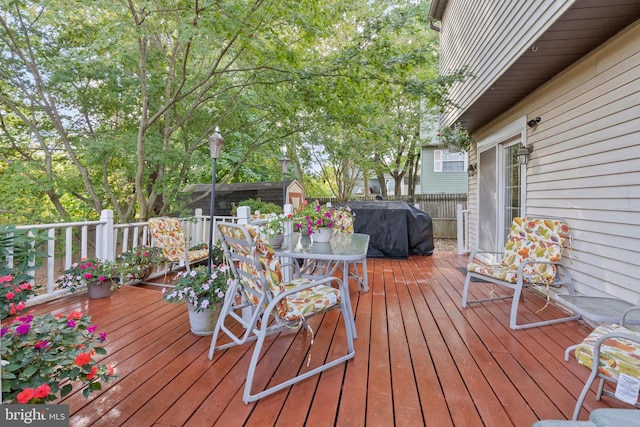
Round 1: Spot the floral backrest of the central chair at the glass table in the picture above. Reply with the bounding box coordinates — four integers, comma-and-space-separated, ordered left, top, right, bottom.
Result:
217, 222, 289, 318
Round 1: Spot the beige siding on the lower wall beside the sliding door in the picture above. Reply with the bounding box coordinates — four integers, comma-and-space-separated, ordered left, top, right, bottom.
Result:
470, 21, 640, 304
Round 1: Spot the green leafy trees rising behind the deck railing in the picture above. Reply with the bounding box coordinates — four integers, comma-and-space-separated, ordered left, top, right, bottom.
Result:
0, 0, 463, 223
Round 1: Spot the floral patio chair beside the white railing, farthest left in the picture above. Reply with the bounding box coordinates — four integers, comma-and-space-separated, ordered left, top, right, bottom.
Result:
148, 217, 209, 271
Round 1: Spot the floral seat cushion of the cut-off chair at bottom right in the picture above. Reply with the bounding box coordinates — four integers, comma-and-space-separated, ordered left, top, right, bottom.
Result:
575, 323, 640, 380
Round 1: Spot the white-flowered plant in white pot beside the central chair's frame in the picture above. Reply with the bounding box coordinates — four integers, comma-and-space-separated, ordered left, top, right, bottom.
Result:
162, 263, 231, 335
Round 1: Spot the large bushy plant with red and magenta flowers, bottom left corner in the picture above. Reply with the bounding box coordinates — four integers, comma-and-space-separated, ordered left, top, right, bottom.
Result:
0, 311, 117, 404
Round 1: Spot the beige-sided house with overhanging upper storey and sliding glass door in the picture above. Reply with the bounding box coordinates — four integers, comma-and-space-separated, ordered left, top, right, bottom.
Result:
429, 0, 640, 304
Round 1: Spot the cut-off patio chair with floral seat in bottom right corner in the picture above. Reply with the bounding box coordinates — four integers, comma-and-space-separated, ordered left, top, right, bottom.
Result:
565, 306, 640, 420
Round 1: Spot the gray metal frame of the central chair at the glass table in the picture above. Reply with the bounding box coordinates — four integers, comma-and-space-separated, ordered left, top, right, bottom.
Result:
209, 222, 355, 404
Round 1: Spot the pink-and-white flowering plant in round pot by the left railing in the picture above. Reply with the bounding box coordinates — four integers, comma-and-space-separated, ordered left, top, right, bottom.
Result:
56, 258, 122, 299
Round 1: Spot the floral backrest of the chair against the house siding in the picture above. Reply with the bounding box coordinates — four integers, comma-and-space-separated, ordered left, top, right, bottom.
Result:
501, 217, 569, 283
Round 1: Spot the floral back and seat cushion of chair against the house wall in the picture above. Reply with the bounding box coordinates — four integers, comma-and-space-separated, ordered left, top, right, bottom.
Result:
467, 218, 569, 285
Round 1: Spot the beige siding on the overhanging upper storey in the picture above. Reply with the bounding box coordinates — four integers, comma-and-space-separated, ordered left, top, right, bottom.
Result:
440, 0, 575, 125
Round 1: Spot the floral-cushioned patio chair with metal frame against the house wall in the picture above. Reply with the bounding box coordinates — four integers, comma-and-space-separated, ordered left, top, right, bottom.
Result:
462, 218, 580, 330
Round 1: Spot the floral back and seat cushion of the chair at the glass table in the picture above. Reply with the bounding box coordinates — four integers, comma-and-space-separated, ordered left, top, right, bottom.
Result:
221, 226, 340, 321
